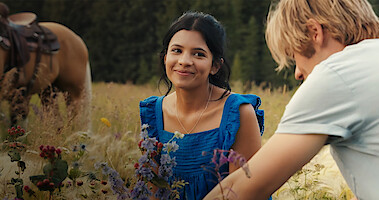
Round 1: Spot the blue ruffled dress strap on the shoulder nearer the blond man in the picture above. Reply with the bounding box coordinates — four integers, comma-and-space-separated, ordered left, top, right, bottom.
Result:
222, 94, 264, 150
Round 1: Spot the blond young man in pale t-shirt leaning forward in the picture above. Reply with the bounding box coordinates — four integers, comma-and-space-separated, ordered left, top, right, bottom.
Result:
205, 0, 379, 200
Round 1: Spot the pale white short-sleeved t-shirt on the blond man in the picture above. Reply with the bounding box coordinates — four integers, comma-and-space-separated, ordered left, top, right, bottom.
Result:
276, 39, 379, 200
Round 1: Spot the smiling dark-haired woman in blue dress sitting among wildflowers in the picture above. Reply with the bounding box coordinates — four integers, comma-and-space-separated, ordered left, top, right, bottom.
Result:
140, 12, 263, 199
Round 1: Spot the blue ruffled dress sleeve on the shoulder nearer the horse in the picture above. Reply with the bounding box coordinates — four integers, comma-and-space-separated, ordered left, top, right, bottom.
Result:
139, 96, 159, 137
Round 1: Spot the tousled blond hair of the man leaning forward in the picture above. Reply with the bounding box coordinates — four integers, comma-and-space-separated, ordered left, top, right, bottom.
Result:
266, 0, 379, 70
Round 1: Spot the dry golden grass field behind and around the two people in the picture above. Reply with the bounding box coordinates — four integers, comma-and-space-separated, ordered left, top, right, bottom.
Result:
0, 83, 353, 199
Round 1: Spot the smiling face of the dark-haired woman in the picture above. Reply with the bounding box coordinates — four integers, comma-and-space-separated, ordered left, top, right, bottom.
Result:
165, 30, 217, 88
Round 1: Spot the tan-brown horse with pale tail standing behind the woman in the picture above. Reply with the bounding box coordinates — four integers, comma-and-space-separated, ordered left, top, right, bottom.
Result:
0, 4, 91, 131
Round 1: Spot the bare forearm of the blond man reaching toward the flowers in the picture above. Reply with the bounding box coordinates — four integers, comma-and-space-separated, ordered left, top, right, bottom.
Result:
204, 134, 328, 200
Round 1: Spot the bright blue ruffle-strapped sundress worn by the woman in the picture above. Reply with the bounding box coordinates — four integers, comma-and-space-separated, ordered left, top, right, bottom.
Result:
140, 93, 264, 200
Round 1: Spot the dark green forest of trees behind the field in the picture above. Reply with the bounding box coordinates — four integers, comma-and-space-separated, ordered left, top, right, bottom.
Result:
3, 0, 379, 87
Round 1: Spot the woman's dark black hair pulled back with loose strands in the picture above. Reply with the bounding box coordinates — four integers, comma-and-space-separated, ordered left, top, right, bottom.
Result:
159, 11, 231, 99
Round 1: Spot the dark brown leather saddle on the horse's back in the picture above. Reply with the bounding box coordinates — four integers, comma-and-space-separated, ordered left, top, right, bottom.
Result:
0, 12, 60, 72
